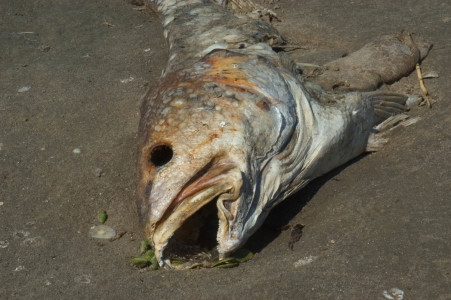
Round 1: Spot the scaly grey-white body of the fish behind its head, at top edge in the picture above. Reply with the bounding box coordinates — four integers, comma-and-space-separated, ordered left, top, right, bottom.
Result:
150, 0, 283, 72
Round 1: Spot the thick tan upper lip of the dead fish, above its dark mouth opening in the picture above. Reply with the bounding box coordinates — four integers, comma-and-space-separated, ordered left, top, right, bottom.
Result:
146, 161, 240, 267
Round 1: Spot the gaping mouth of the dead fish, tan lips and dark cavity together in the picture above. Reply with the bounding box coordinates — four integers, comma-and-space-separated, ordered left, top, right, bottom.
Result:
148, 162, 241, 267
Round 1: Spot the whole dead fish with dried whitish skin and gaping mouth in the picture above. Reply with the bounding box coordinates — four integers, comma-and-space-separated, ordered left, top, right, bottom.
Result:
136, 0, 430, 267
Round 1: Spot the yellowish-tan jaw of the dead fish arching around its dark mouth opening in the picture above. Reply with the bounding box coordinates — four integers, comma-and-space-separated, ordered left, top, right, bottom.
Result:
145, 161, 245, 266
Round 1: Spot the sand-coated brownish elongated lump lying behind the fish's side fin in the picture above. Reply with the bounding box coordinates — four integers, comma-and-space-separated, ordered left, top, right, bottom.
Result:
306, 31, 430, 91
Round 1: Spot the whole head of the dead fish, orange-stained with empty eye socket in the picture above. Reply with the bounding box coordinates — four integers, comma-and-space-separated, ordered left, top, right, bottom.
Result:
137, 49, 296, 265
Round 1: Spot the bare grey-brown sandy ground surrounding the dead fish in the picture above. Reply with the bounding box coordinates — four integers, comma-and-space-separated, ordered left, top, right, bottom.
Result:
0, 0, 451, 299
